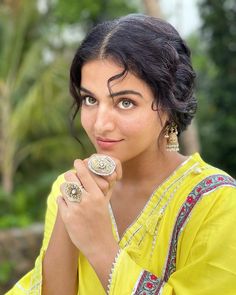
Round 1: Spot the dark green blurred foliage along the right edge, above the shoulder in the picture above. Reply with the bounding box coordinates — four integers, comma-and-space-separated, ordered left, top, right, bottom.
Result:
195, 0, 236, 177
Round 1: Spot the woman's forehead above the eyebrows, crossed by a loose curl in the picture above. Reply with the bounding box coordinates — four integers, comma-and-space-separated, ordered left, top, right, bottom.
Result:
81, 59, 151, 93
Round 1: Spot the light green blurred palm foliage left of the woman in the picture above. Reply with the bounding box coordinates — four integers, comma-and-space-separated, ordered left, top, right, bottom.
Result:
0, 0, 137, 228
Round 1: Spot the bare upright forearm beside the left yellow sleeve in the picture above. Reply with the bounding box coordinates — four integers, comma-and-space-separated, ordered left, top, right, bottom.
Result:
42, 213, 78, 295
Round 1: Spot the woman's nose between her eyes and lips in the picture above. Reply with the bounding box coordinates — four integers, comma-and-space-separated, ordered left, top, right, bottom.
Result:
94, 104, 115, 134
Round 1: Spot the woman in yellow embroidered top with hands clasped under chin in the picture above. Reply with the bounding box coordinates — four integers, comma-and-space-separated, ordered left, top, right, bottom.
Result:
7, 15, 236, 295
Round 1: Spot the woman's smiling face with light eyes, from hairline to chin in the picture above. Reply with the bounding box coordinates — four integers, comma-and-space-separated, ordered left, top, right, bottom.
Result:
80, 59, 166, 162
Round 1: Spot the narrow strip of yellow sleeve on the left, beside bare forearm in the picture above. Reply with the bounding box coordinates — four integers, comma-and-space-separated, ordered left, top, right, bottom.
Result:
5, 175, 64, 295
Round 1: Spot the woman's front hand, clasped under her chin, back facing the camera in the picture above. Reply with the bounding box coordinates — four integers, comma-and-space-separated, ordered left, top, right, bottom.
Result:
58, 155, 122, 259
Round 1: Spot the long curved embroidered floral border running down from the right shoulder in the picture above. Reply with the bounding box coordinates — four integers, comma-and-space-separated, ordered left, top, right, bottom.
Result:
163, 174, 236, 282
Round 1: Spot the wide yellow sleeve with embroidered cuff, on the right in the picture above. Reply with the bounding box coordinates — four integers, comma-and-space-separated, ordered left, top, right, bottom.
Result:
109, 187, 236, 295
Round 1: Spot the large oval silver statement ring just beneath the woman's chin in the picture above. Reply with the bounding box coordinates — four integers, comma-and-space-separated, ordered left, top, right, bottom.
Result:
88, 155, 116, 176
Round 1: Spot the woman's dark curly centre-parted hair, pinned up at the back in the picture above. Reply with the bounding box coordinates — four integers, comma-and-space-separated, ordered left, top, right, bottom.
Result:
70, 14, 197, 133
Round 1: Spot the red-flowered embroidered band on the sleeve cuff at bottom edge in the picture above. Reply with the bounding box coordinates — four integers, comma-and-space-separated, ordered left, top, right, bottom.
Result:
132, 270, 164, 295
